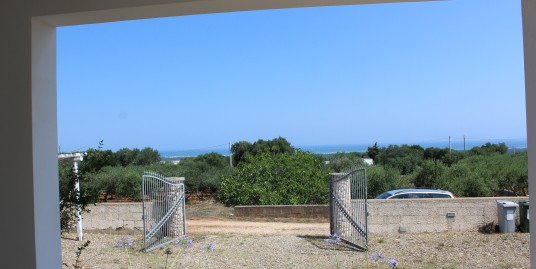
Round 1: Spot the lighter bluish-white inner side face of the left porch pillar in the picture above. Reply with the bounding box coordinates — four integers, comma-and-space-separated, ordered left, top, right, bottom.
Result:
31, 19, 61, 268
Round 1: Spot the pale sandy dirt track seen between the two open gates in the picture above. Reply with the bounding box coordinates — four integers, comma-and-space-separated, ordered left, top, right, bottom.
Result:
186, 219, 329, 236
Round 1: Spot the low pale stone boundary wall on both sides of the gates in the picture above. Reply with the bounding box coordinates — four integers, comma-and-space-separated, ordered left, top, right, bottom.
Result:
83, 197, 529, 233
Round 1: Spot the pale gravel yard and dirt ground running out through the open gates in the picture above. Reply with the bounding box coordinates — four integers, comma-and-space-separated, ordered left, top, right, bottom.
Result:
62, 204, 530, 269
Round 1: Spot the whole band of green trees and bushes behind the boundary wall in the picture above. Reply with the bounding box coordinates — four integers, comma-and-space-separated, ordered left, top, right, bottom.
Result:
59, 137, 528, 229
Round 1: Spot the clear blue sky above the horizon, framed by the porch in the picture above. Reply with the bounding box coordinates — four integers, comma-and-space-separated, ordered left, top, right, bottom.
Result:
57, 0, 526, 151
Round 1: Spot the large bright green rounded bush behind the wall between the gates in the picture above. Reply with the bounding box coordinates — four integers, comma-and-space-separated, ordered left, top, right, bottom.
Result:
219, 151, 329, 205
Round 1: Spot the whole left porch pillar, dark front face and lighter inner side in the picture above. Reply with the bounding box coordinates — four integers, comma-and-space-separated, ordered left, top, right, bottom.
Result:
0, 6, 61, 268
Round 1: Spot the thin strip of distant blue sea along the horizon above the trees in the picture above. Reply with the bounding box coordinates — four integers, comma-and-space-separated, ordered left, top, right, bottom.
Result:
159, 139, 527, 159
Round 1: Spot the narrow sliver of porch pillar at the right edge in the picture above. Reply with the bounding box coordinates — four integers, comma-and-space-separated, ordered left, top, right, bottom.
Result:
521, 0, 536, 264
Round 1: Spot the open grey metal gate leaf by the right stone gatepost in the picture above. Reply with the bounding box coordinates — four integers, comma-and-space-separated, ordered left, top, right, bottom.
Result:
329, 167, 368, 250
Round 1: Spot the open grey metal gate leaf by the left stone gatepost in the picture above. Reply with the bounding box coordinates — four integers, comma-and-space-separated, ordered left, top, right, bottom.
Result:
142, 172, 186, 252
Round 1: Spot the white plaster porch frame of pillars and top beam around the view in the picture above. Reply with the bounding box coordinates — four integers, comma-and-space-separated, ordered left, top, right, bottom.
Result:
0, 0, 536, 268
